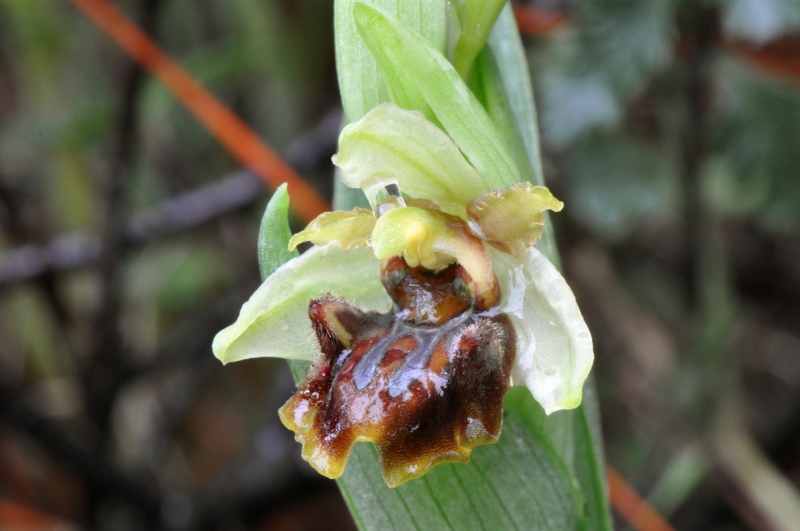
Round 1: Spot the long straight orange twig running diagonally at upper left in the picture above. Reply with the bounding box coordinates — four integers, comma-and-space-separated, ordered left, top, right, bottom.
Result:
72, 0, 330, 221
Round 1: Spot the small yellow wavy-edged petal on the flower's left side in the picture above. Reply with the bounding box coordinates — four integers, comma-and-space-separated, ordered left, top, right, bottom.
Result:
289, 208, 375, 249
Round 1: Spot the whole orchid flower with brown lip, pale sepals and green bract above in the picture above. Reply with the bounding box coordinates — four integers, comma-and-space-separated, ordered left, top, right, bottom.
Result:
213, 3, 593, 486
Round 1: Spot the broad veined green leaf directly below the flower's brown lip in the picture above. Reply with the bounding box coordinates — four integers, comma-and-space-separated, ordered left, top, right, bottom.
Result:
339, 390, 583, 531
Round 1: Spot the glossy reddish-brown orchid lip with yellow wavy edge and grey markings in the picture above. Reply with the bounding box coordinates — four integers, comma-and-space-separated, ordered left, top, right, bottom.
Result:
280, 258, 515, 487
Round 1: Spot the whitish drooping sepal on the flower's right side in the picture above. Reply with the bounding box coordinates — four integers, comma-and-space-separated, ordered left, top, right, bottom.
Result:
489, 247, 594, 415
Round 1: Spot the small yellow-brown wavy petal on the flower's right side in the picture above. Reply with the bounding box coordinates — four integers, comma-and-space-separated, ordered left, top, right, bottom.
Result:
467, 183, 564, 256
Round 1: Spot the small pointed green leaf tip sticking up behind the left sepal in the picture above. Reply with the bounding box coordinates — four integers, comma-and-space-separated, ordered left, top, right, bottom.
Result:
258, 183, 298, 280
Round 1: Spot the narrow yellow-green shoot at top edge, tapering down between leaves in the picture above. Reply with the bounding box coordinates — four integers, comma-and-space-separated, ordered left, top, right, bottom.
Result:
453, 0, 506, 79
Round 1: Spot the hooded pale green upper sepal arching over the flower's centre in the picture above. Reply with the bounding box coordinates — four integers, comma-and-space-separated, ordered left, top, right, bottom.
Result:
333, 103, 486, 205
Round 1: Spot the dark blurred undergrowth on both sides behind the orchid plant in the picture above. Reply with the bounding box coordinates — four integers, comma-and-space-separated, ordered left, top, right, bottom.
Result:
0, 0, 800, 530
